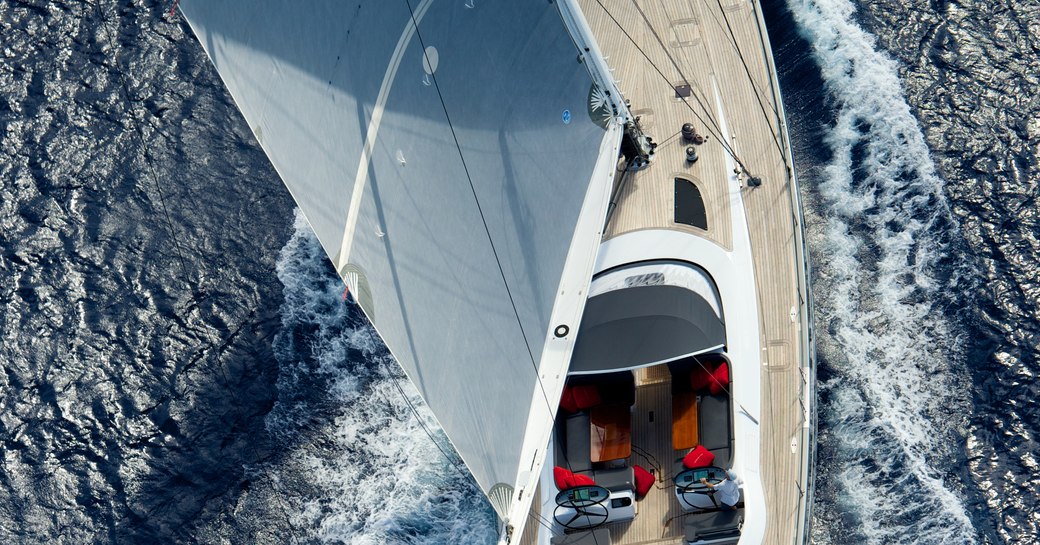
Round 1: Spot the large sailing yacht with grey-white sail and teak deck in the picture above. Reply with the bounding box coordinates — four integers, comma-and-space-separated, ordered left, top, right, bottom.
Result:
179, 0, 814, 545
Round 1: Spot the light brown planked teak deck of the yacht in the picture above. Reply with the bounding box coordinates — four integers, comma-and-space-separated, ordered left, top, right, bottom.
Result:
525, 0, 814, 545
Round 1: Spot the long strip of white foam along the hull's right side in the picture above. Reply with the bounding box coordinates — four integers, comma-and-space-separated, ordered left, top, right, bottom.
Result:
789, 0, 977, 544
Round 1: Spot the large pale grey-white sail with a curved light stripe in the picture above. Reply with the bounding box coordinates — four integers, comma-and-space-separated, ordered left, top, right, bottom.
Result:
180, 0, 621, 522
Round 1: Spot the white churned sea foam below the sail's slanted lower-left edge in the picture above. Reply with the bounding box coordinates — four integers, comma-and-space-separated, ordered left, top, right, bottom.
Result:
267, 213, 497, 545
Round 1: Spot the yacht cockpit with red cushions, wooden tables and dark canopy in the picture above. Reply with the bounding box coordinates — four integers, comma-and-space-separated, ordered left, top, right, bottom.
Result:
551, 262, 743, 545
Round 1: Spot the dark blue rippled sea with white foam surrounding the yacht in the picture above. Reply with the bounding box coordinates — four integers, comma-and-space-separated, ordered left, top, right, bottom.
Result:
0, 0, 1040, 545
